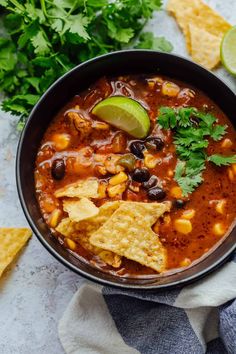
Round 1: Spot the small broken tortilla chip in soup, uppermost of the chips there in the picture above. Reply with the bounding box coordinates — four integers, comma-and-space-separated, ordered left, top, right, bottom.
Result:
54, 179, 98, 198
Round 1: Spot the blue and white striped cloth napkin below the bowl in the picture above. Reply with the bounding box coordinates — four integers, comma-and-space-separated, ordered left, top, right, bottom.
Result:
58, 254, 236, 354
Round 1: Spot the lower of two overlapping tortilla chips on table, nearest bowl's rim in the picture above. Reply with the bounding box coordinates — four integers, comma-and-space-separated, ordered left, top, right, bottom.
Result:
189, 24, 221, 70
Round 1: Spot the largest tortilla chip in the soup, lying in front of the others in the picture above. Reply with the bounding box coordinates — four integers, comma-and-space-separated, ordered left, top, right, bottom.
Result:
90, 202, 170, 272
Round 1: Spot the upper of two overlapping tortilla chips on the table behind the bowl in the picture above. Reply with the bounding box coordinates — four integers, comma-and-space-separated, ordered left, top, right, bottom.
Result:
167, 0, 232, 54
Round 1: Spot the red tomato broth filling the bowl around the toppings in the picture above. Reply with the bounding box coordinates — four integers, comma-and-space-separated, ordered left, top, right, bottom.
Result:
35, 76, 236, 276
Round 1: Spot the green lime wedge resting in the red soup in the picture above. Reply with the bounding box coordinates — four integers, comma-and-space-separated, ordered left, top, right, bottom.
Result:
92, 96, 150, 139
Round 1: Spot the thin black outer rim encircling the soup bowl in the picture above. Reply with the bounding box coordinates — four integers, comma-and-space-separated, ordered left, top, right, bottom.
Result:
15, 49, 236, 291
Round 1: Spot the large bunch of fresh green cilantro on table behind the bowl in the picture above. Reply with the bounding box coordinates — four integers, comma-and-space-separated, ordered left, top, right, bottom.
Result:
0, 0, 172, 127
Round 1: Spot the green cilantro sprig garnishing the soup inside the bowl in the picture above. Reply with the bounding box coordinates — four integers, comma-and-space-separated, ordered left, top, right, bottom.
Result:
157, 107, 236, 196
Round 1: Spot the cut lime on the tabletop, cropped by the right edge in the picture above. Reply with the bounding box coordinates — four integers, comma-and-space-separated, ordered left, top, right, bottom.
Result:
220, 26, 236, 75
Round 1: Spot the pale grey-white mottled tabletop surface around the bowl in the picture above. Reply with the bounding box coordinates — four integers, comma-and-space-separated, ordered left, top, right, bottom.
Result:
0, 0, 236, 354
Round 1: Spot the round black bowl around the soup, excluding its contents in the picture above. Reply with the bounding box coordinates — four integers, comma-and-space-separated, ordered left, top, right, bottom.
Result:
16, 50, 236, 290
